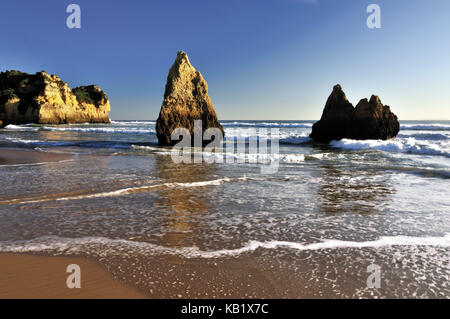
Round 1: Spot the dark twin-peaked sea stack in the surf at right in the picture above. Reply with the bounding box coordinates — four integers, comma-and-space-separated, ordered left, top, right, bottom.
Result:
310, 84, 400, 143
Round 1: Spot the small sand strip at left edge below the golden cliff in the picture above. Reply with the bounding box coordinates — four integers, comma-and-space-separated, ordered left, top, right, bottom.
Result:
0, 148, 72, 165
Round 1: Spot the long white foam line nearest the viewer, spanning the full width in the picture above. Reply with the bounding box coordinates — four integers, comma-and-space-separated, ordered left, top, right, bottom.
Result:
0, 234, 450, 258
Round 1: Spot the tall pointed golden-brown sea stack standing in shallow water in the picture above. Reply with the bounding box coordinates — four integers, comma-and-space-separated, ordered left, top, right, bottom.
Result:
156, 51, 224, 146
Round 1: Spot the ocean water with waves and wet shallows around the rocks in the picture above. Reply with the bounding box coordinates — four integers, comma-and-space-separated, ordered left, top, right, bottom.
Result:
0, 121, 450, 298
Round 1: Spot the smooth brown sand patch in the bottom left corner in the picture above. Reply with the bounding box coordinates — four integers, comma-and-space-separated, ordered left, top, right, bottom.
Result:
0, 254, 147, 299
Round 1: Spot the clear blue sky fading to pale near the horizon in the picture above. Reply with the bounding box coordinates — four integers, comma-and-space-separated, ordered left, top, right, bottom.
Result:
0, 0, 450, 120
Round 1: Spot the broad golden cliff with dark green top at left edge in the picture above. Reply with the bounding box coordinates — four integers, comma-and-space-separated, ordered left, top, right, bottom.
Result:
0, 71, 110, 125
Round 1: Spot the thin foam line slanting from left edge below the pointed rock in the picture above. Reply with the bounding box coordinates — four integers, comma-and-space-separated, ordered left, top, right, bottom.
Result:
0, 176, 249, 205
